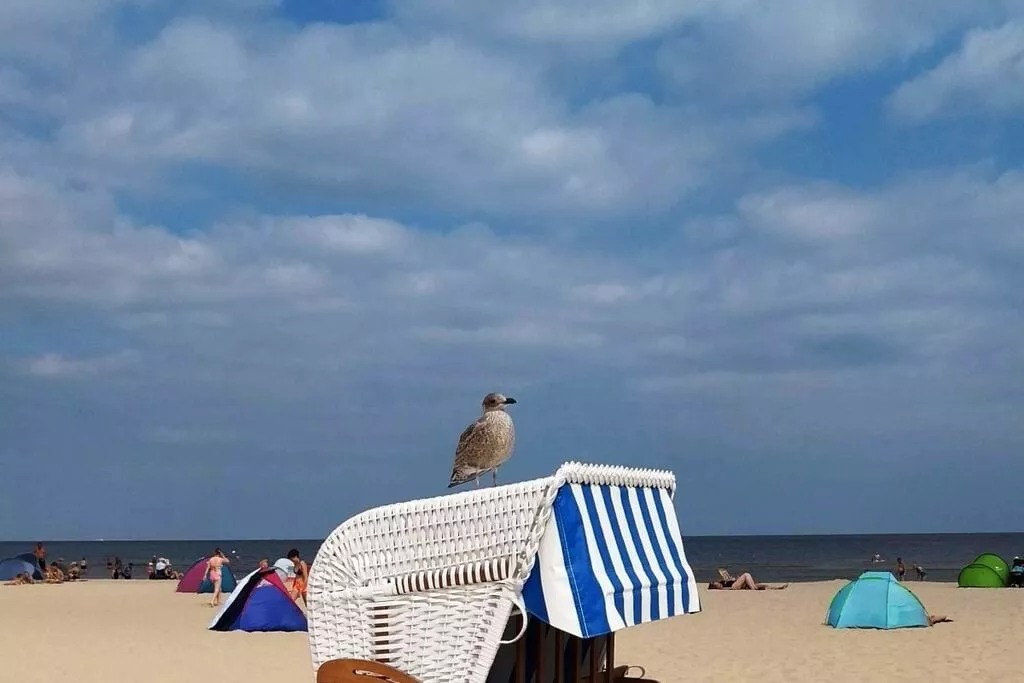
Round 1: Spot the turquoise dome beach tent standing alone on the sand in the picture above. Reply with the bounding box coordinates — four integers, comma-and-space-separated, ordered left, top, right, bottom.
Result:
827, 571, 929, 629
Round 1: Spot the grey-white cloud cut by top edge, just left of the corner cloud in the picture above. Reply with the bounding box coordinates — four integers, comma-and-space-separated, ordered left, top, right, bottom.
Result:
659, 0, 1000, 101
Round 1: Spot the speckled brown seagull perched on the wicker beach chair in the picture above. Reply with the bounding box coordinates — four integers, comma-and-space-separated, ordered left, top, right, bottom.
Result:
449, 393, 516, 488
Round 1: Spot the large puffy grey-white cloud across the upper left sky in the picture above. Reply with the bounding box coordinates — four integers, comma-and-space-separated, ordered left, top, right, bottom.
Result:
0, 17, 813, 220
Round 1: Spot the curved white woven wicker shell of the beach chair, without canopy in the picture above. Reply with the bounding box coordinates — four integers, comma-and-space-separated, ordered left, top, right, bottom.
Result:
308, 477, 554, 682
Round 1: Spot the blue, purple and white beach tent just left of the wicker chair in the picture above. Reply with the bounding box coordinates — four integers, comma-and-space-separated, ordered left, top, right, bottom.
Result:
209, 568, 308, 631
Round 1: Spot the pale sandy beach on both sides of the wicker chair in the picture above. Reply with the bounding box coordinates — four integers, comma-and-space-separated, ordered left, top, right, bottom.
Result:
0, 581, 1024, 683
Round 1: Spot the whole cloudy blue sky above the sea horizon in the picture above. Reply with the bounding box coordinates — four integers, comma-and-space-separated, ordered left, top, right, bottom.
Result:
0, 0, 1024, 539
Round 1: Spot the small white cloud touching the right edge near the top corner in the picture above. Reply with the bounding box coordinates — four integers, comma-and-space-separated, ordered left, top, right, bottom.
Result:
888, 20, 1024, 122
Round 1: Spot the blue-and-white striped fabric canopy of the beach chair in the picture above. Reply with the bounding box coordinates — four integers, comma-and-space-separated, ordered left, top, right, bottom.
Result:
522, 483, 700, 638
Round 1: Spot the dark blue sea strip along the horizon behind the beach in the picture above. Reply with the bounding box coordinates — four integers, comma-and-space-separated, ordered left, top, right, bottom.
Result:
8, 533, 1024, 583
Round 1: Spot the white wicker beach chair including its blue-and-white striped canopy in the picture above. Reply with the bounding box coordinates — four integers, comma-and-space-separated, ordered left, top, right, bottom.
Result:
307, 463, 700, 683
